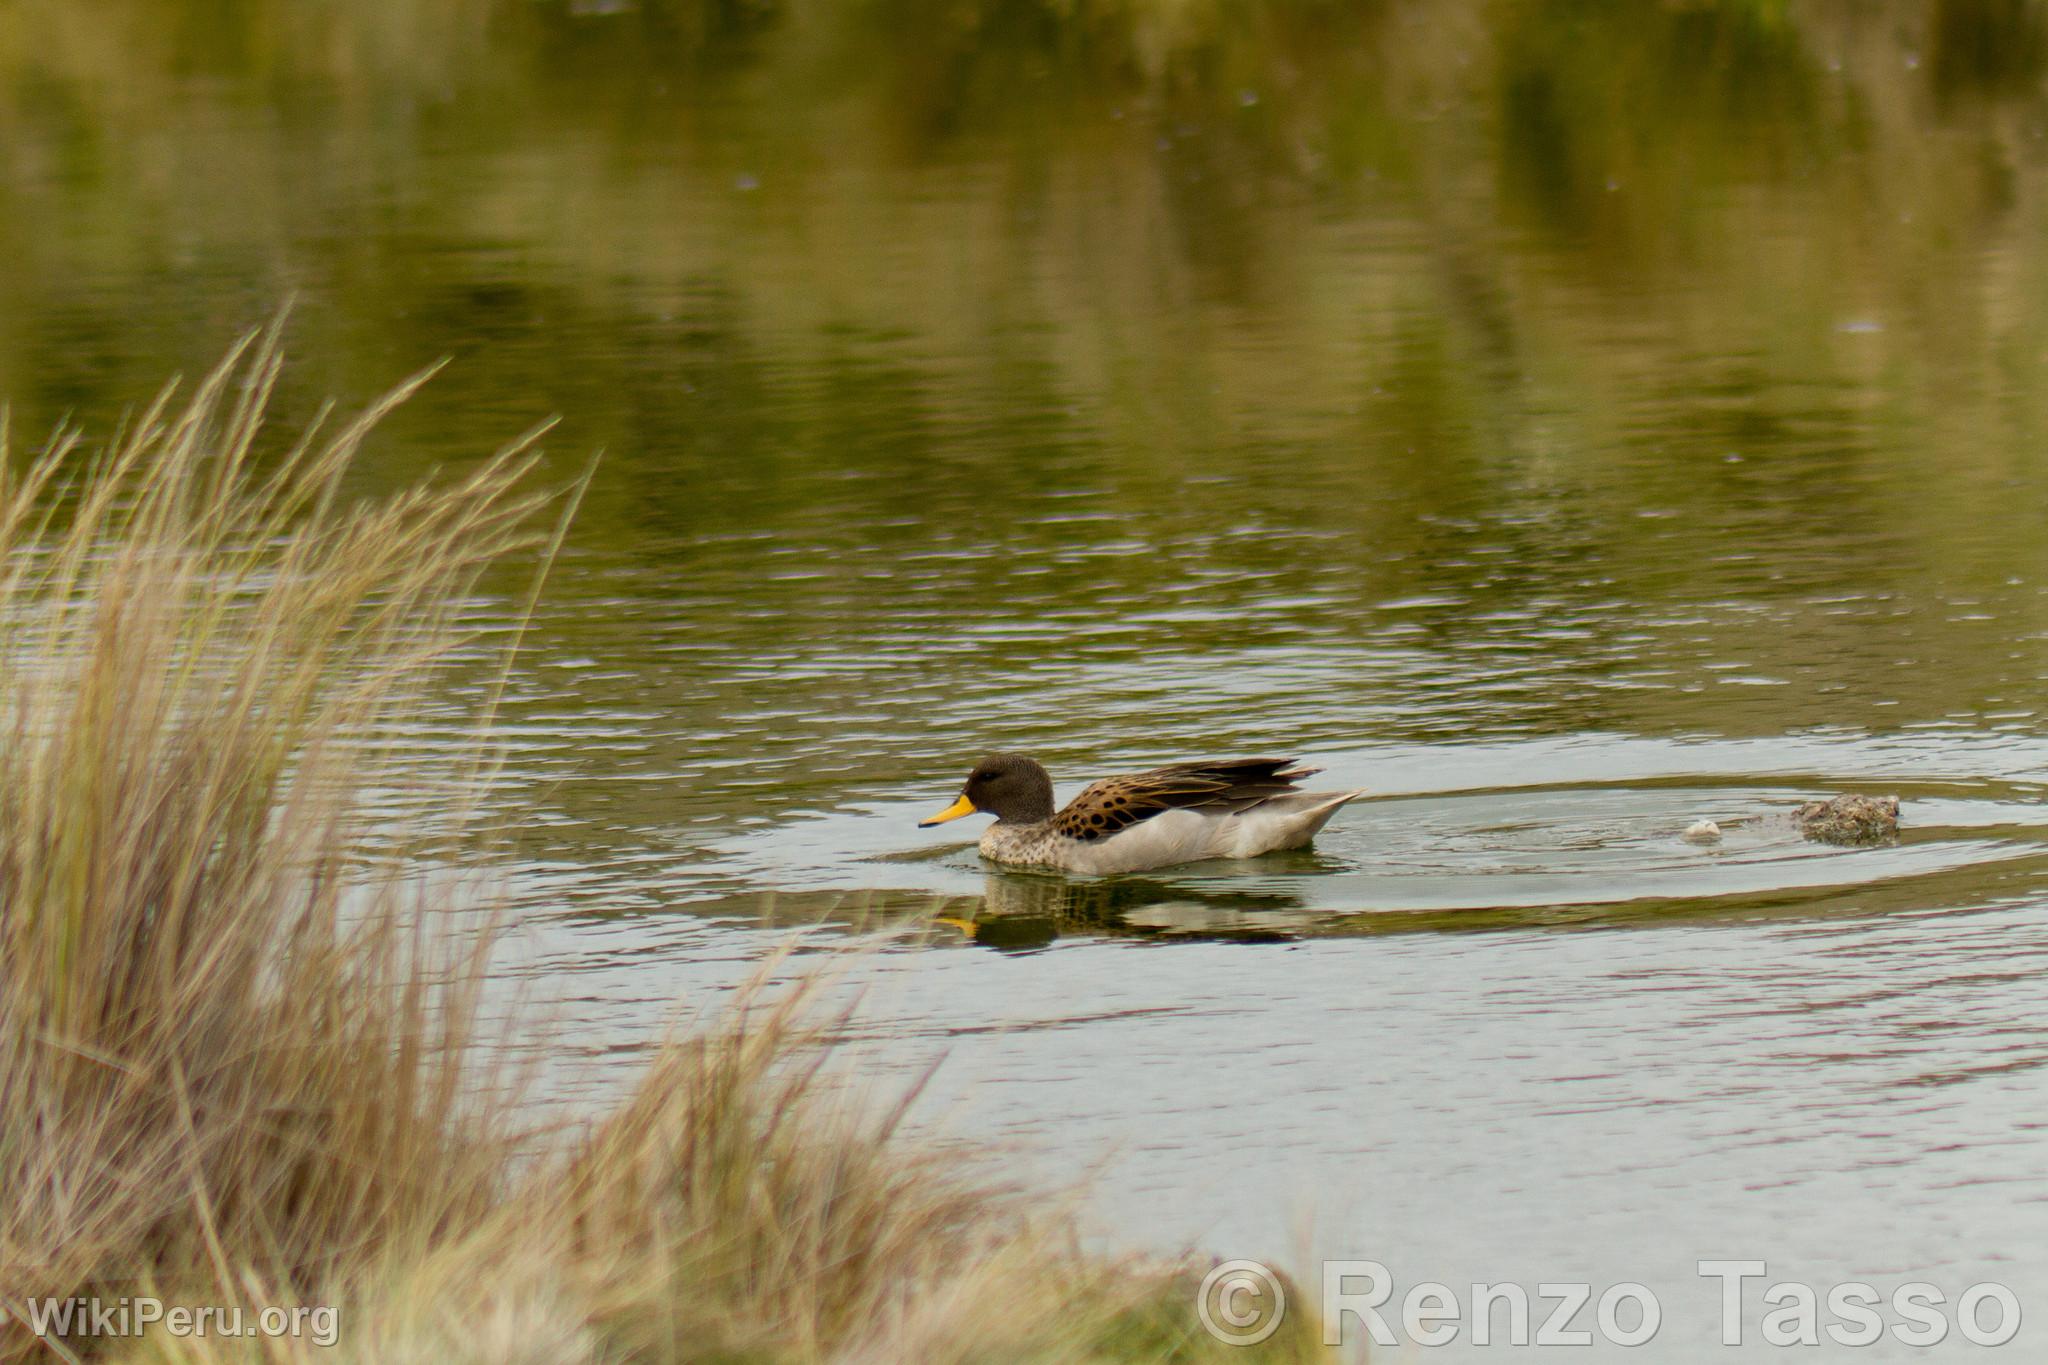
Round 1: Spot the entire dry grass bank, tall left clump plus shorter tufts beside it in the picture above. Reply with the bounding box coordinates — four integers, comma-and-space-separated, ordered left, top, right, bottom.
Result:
0, 336, 1307, 1365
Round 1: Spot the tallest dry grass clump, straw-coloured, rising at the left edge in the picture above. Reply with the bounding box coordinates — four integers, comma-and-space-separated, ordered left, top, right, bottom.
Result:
0, 327, 541, 1357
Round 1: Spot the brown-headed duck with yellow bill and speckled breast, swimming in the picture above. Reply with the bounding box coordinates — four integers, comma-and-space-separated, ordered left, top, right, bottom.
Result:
918, 753, 1366, 874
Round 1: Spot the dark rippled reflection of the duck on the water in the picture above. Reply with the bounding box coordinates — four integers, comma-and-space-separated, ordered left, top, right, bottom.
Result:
934, 872, 1303, 952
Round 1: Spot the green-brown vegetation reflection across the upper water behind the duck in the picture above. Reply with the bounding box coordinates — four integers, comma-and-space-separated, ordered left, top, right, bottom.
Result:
0, 0, 2048, 823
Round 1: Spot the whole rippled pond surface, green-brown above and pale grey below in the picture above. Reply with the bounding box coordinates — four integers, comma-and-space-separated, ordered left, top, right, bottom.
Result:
12, 0, 2048, 1359
